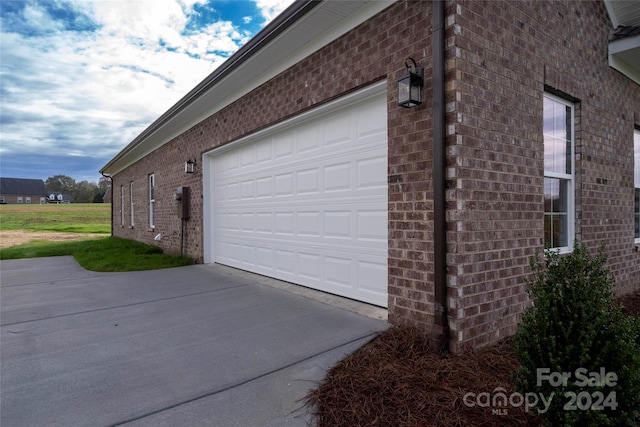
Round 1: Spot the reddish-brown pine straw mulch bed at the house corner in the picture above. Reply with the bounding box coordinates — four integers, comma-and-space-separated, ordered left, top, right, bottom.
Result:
305, 292, 640, 427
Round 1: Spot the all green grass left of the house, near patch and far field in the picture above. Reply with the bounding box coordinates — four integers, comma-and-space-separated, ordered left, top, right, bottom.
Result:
0, 203, 193, 271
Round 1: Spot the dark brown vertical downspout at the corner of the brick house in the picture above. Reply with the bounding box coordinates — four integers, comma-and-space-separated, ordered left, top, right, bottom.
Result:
431, 0, 449, 353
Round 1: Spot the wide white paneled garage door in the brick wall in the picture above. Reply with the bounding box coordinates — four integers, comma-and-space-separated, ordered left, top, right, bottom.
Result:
208, 85, 387, 307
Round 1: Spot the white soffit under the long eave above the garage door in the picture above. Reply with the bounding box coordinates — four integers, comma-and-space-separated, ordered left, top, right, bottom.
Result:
101, 0, 395, 175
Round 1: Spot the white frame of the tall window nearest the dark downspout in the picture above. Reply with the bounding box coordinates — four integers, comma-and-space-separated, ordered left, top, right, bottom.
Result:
542, 92, 576, 253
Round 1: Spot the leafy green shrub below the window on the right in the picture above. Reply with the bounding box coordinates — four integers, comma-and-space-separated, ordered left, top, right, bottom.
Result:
514, 243, 640, 427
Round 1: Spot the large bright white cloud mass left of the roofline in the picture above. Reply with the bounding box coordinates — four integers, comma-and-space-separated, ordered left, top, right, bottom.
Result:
2, 0, 240, 159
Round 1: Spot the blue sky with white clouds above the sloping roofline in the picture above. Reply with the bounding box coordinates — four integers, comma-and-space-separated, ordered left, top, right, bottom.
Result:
0, 0, 293, 182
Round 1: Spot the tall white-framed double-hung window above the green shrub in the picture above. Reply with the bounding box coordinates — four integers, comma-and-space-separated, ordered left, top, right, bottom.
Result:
543, 94, 575, 252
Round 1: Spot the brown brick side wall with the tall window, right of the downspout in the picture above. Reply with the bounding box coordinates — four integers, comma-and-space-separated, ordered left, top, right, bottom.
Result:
447, 0, 640, 349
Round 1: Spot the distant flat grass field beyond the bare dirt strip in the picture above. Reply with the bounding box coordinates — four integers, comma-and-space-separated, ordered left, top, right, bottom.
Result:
0, 203, 111, 234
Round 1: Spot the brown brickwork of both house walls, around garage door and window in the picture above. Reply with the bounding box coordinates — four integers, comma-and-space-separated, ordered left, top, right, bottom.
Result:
114, 0, 640, 351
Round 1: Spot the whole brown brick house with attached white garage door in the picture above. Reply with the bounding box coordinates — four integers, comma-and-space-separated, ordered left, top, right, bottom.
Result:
101, 0, 640, 351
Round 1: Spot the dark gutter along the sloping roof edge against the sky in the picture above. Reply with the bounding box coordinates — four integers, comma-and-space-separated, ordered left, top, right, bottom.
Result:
100, 0, 322, 173
